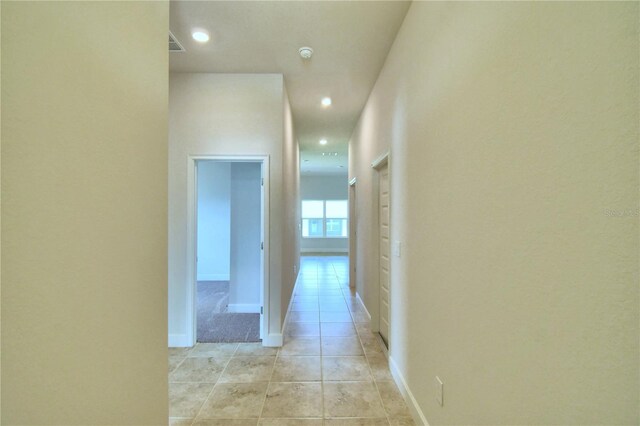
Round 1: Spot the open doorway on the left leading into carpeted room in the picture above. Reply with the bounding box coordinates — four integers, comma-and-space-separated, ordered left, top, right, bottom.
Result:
188, 156, 268, 344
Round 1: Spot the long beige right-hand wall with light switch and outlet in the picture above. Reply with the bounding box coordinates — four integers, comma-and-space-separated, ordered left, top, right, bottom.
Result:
350, 2, 640, 424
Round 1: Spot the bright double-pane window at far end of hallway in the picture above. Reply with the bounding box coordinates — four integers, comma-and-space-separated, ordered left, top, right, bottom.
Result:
302, 200, 349, 238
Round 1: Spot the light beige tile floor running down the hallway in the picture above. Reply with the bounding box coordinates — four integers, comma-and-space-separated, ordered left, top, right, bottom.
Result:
169, 257, 414, 426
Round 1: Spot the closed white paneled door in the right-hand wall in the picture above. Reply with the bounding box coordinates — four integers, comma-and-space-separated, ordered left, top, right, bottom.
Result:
378, 165, 389, 347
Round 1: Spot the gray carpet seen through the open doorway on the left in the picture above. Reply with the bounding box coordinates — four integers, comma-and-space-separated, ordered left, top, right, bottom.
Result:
197, 281, 260, 343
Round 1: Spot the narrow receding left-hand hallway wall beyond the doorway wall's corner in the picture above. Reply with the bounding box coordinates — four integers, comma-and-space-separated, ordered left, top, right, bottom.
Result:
280, 88, 300, 323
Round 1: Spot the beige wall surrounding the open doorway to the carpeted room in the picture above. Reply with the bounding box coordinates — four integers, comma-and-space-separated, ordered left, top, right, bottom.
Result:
169, 73, 297, 341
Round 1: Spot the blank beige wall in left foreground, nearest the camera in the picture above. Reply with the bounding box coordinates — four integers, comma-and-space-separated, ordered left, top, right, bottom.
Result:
1, 1, 169, 425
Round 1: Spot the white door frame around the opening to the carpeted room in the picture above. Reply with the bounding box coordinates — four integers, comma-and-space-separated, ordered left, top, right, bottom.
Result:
186, 155, 270, 346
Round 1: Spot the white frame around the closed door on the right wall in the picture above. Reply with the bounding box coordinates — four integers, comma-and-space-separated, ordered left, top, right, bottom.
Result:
370, 151, 393, 355
